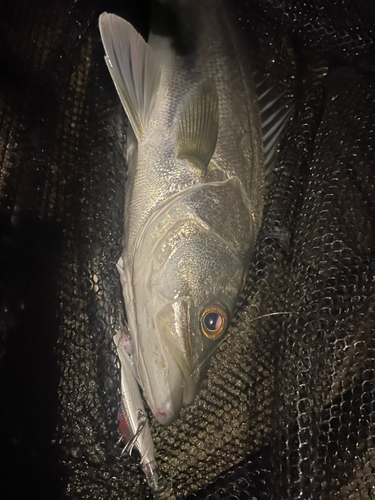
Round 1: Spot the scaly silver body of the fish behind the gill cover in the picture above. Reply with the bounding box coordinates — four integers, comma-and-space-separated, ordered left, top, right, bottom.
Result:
125, 0, 264, 250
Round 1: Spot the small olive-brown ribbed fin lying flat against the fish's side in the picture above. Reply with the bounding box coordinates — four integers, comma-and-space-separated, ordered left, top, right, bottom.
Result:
177, 80, 219, 170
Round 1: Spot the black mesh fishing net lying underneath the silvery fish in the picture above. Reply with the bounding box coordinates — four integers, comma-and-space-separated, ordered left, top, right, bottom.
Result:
0, 0, 375, 500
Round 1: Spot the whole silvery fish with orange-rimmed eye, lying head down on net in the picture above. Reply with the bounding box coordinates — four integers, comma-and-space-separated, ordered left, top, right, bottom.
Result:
99, 0, 288, 425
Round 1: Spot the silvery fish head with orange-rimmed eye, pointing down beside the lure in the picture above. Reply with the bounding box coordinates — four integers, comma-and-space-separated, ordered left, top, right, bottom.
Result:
135, 219, 247, 424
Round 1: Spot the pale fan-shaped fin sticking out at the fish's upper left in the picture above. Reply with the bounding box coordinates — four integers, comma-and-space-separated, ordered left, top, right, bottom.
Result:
99, 12, 160, 139
